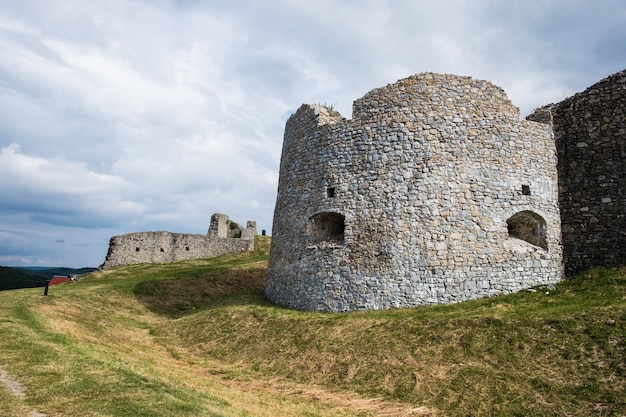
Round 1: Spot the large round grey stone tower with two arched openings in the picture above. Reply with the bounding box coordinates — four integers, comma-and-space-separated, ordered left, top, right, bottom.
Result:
266, 73, 563, 311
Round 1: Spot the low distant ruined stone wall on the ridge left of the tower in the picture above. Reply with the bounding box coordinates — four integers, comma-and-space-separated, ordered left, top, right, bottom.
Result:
100, 213, 256, 269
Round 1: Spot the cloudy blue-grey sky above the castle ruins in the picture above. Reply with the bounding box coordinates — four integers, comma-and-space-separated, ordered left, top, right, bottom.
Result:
0, 0, 626, 267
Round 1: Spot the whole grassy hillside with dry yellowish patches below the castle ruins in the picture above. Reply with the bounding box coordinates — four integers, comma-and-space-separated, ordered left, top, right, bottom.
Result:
0, 238, 626, 417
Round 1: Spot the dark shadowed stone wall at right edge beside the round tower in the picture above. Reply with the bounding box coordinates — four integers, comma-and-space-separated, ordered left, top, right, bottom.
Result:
528, 70, 626, 275
